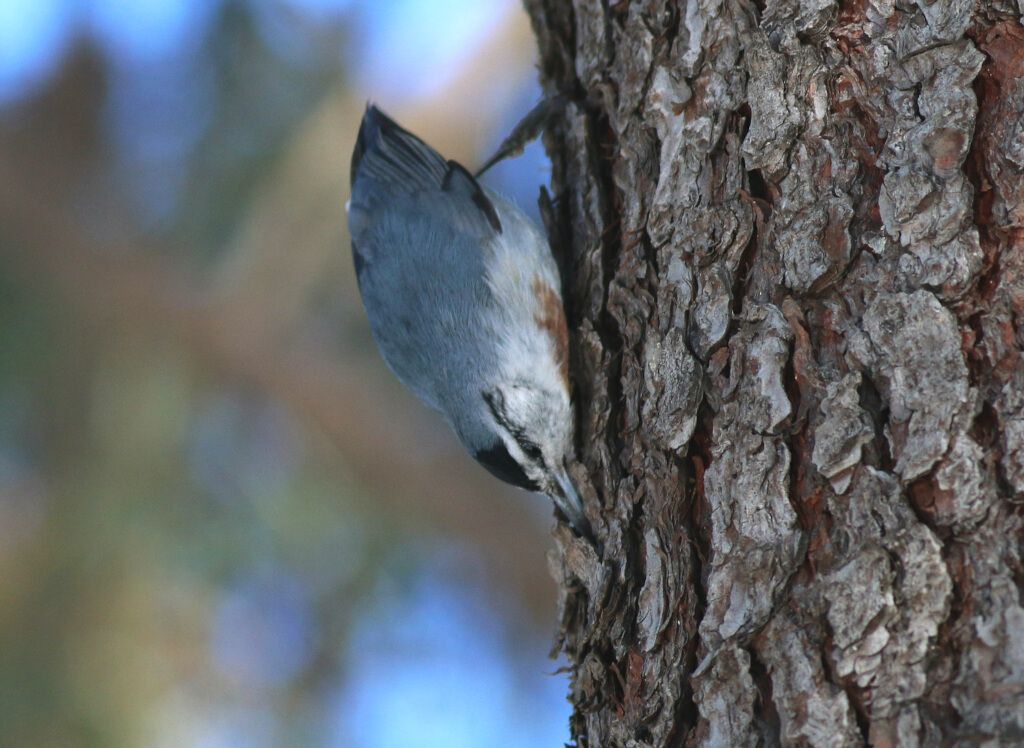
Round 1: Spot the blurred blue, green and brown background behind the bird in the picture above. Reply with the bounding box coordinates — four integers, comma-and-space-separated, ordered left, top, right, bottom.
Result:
0, 0, 569, 748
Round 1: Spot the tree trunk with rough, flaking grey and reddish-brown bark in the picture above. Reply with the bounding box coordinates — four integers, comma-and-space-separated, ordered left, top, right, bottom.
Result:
526, 0, 1024, 748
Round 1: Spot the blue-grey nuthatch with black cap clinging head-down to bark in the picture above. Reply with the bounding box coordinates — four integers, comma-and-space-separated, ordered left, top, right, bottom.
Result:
347, 105, 593, 539
